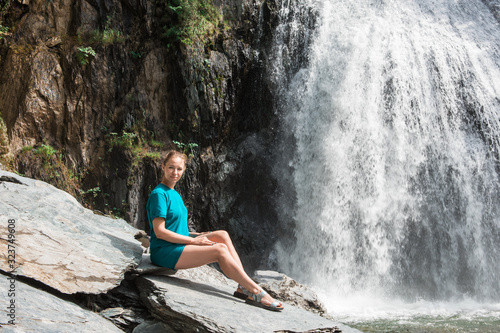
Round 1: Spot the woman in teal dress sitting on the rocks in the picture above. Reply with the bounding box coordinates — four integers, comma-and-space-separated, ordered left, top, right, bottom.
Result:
147, 151, 283, 311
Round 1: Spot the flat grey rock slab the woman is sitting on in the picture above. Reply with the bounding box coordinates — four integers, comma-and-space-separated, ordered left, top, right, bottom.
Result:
136, 266, 359, 333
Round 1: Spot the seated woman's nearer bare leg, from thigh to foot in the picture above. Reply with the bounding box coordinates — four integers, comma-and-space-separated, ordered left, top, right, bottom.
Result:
175, 243, 280, 305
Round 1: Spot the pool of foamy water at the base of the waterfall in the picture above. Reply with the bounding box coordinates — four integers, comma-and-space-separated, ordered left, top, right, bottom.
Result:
324, 297, 500, 333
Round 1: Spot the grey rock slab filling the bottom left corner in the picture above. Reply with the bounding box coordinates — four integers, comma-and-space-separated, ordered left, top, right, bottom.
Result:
0, 274, 123, 333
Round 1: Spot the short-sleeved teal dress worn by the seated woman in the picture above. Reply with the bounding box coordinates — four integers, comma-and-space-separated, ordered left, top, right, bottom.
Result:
146, 184, 189, 269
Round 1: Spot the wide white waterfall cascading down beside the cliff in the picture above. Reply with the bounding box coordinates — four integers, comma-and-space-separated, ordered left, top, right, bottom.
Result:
273, 0, 500, 301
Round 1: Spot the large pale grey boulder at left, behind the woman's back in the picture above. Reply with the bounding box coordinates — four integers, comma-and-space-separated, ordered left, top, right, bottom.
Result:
0, 170, 142, 294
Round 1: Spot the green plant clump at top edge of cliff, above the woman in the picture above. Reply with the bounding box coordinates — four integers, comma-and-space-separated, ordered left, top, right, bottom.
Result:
158, 0, 222, 44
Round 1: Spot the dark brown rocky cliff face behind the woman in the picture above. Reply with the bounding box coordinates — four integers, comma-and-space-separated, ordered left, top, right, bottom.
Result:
0, 0, 284, 265
